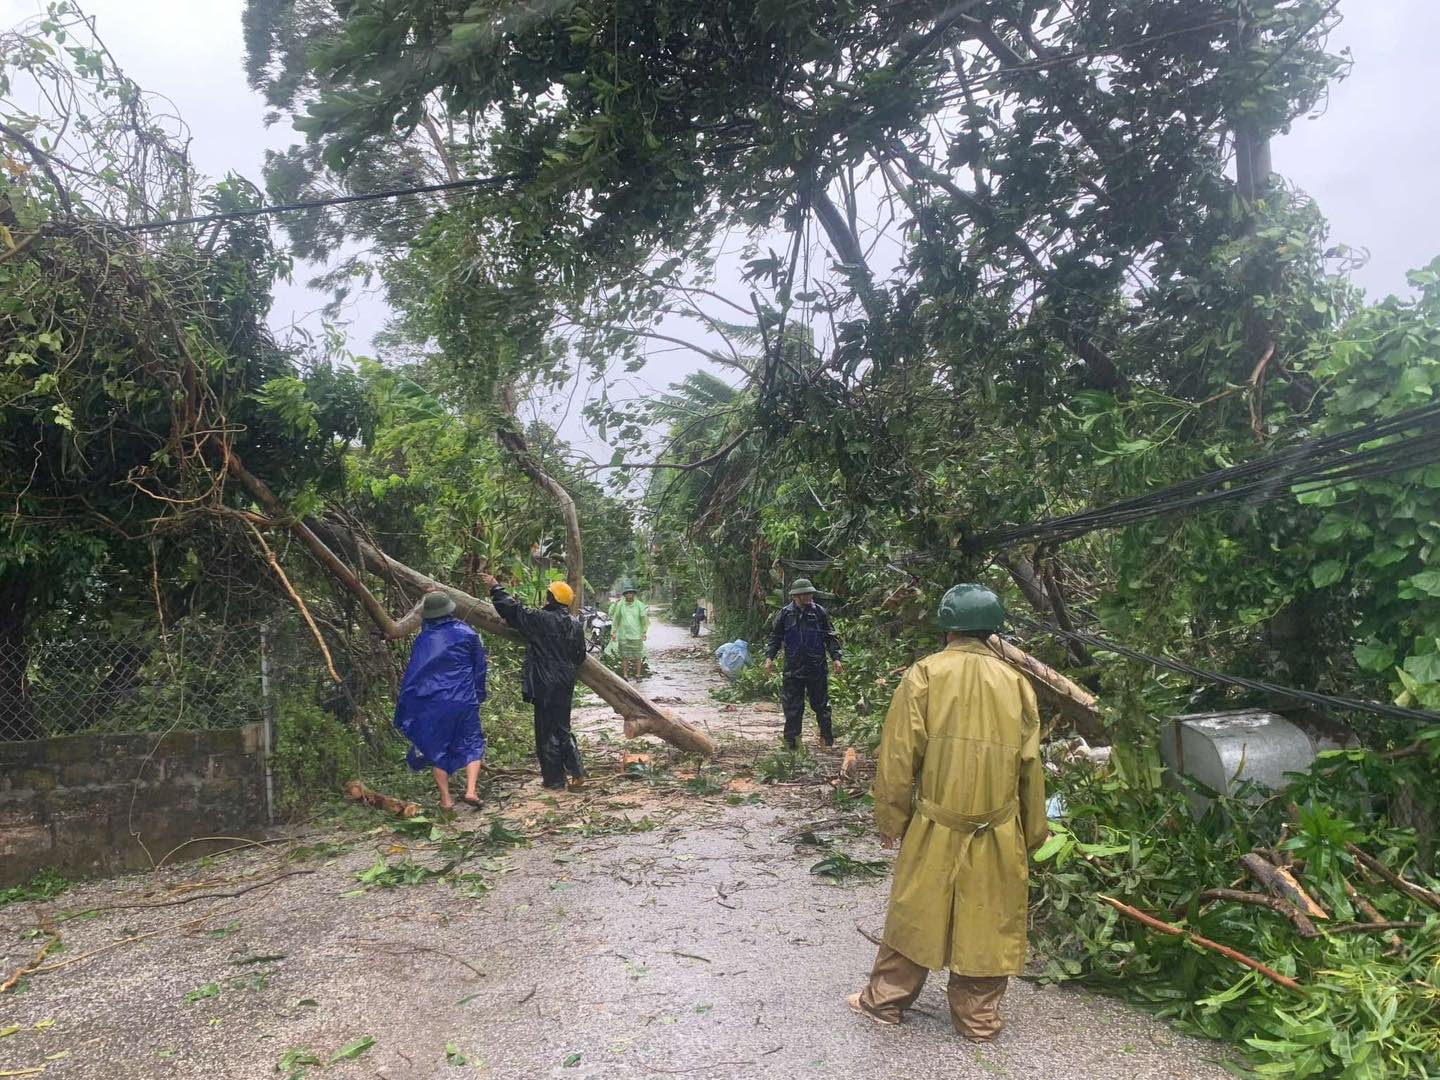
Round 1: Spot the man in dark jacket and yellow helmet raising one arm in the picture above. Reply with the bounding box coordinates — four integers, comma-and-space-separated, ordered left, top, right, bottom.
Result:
480, 573, 585, 791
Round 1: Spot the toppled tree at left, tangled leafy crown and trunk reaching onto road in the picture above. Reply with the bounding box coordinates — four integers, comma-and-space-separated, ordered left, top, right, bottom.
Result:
0, 16, 714, 753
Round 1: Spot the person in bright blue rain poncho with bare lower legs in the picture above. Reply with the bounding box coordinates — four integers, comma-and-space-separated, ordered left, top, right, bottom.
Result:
395, 592, 490, 809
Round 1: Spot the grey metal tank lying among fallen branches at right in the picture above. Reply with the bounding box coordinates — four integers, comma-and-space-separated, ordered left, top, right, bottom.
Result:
1161, 708, 1315, 816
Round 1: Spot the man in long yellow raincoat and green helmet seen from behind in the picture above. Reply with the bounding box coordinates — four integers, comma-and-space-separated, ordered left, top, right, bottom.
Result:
848, 585, 1048, 1041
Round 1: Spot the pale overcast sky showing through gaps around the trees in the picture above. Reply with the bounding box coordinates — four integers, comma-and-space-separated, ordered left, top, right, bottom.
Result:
0, 0, 1440, 446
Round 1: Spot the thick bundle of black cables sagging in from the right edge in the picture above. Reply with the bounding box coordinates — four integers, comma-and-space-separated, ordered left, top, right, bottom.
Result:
965, 403, 1440, 553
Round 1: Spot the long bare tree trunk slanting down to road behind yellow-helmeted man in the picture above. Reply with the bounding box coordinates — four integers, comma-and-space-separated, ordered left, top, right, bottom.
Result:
318, 523, 716, 757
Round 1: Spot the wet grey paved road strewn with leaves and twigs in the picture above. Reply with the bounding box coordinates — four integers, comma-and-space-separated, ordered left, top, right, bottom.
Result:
0, 631, 1227, 1080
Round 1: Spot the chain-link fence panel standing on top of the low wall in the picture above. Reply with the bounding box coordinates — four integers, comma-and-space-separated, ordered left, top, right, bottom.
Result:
0, 622, 265, 742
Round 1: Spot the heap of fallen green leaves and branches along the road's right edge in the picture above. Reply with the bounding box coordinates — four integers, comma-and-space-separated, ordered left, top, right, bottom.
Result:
1031, 755, 1440, 1080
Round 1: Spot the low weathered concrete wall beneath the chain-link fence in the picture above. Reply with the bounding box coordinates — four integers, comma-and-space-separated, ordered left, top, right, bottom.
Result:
0, 724, 265, 886
